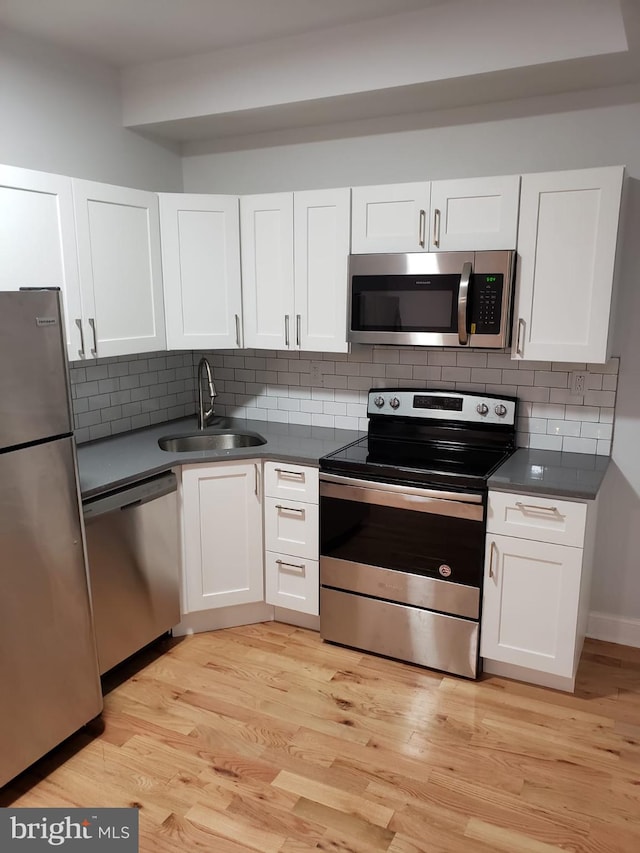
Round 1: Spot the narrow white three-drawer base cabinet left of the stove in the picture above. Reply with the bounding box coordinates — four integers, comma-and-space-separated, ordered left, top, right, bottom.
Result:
264, 462, 320, 616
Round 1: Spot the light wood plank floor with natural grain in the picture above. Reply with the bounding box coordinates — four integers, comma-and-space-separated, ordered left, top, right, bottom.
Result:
0, 623, 640, 853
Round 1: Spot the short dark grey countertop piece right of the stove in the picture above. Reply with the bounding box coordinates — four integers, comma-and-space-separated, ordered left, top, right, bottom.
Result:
489, 447, 610, 500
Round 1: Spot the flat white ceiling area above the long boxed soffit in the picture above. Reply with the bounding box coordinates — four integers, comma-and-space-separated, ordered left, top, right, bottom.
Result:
0, 0, 446, 67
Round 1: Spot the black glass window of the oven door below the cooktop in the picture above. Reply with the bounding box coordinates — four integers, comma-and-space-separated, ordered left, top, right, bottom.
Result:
320, 496, 485, 587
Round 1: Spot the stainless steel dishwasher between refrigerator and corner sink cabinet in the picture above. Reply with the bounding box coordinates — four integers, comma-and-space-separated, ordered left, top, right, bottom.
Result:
83, 473, 180, 675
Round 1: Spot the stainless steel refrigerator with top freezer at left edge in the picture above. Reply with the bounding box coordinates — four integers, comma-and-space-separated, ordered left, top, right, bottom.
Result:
0, 290, 102, 785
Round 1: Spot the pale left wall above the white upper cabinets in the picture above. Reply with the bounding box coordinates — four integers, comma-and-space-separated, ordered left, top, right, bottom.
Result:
0, 30, 182, 191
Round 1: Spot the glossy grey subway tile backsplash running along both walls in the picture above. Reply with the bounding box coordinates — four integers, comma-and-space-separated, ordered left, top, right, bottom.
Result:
70, 345, 619, 454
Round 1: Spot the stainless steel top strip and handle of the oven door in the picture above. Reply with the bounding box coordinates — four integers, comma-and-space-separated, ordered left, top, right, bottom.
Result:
320, 474, 484, 521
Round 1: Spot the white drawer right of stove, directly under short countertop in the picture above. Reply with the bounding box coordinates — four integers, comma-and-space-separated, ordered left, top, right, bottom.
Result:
487, 492, 587, 548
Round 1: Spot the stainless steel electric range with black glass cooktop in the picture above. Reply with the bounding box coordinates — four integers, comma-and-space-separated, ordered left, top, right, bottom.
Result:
320, 389, 517, 678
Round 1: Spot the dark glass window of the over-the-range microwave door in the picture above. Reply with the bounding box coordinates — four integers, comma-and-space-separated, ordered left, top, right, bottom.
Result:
351, 275, 460, 332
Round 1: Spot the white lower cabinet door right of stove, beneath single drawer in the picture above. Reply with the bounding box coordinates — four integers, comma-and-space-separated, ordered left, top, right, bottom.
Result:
480, 534, 582, 677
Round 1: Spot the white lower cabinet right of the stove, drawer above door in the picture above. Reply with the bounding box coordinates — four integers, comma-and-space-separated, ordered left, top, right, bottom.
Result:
480, 492, 594, 690
